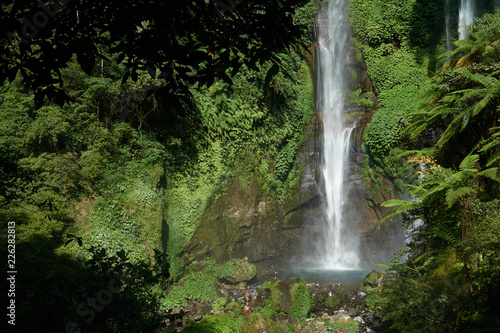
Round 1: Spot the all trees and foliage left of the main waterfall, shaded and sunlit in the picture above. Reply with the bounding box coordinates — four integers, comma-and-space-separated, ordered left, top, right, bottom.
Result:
0, 1, 315, 332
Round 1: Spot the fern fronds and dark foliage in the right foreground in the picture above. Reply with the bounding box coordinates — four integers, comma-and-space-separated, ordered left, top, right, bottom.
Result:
366, 7, 500, 332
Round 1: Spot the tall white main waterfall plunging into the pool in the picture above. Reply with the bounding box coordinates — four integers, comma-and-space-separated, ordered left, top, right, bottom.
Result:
317, 0, 359, 270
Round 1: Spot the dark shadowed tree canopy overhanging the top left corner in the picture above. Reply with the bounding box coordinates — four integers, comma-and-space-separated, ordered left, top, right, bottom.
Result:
0, 0, 313, 106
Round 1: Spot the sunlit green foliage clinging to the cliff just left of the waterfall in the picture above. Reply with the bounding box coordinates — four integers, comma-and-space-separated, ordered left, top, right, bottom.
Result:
165, 53, 314, 272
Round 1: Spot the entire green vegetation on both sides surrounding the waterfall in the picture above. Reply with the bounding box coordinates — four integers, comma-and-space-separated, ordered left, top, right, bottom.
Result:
0, 0, 500, 332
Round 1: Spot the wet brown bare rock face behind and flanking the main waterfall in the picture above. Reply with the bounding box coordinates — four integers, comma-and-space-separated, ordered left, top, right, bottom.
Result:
184, 30, 404, 275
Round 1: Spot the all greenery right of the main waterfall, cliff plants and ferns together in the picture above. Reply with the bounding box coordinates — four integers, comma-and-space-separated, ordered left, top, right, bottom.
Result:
351, 0, 500, 332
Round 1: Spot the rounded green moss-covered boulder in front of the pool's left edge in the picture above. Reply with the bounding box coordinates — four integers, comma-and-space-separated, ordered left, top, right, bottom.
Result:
271, 278, 314, 318
